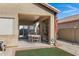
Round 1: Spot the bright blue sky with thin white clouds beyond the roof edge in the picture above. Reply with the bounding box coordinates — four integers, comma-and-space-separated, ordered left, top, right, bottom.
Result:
49, 3, 79, 20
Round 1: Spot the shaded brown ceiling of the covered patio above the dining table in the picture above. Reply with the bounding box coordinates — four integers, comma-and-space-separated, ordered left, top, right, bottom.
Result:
18, 14, 49, 25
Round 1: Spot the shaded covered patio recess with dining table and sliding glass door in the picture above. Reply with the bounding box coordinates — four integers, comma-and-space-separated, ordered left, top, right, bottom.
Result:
18, 13, 50, 46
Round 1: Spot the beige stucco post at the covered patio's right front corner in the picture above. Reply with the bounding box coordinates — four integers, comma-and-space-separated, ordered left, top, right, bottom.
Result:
49, 15, 56, 46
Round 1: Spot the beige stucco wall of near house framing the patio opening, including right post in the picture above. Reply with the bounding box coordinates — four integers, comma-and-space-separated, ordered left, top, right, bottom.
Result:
0, 4, 54, 46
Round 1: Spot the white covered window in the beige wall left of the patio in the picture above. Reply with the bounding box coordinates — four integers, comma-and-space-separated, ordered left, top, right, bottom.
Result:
0, 18, 13, 35
